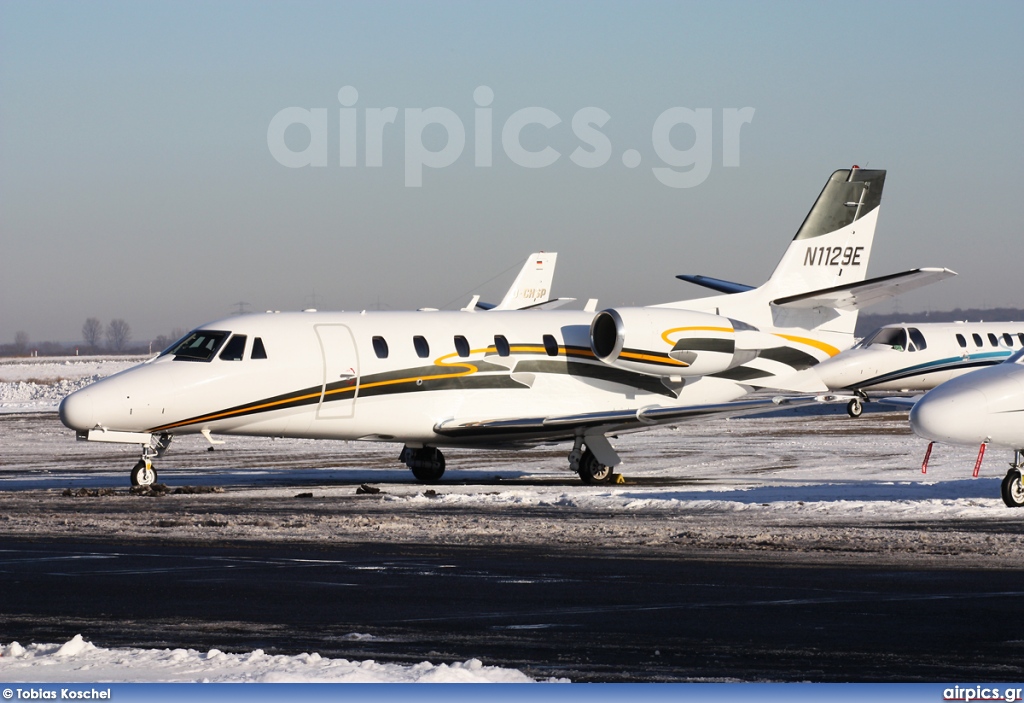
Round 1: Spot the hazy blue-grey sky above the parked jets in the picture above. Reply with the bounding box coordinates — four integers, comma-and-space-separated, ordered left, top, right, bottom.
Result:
0, 0, 1024, 344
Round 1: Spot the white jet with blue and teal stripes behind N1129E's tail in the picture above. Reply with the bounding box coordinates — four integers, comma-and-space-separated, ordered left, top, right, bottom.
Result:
814, 322, 1024, 418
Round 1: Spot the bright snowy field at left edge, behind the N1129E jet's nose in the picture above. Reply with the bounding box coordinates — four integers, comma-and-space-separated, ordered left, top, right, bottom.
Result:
0, 356, 147, 412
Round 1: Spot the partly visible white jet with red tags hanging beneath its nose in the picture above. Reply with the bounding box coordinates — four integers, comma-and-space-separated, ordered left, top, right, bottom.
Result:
910, 349, 1024, 508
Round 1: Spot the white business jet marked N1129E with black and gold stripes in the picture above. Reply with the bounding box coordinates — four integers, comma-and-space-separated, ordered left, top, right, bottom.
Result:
60, 167, 951, 484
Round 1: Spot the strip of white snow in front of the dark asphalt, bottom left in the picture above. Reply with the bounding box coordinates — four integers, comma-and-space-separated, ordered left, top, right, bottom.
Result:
0, 633, 554, 684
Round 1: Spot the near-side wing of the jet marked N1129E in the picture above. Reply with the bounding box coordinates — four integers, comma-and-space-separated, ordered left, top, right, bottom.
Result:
434, 395, 834, 441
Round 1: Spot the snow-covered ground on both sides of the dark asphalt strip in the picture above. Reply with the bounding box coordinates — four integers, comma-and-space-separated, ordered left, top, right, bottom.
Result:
0, 357, 1024, 682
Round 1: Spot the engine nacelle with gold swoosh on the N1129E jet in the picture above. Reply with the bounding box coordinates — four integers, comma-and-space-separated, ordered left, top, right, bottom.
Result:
590, 308, 761, 377
